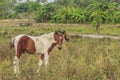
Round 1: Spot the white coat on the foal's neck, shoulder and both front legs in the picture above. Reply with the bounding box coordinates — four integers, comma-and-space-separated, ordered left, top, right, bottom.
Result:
29, 32, 56, 73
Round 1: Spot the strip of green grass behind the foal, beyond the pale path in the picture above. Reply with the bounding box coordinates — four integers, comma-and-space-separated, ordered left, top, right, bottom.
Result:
0, 24, 120, 37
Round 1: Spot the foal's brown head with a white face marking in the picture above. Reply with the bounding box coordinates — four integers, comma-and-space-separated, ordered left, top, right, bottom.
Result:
54, 31, 69, 50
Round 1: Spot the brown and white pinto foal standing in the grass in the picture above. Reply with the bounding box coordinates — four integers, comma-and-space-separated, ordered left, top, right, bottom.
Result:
10, 31, 69, 77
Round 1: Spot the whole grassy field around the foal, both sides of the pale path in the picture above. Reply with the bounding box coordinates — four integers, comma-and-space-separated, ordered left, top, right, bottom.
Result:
0, 20, 120, 80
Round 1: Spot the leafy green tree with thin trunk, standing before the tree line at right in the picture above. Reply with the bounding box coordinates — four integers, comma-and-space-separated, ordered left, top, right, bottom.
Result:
88, 0, 116, 33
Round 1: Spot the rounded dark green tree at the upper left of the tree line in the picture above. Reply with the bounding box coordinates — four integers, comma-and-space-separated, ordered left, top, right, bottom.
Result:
14, 2, 41, 18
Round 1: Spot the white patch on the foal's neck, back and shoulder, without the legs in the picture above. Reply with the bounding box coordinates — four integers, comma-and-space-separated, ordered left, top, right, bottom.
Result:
29, 33, 56, 54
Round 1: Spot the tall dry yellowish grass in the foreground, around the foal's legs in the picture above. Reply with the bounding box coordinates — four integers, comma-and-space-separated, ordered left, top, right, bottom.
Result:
0, 38, 120, 80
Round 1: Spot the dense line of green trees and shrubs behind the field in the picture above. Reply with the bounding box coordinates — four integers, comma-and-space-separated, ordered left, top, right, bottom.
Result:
0, 0, 120, 26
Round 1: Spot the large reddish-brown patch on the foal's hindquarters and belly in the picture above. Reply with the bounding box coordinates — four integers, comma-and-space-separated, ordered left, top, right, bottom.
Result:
17, 36, 36, 58
